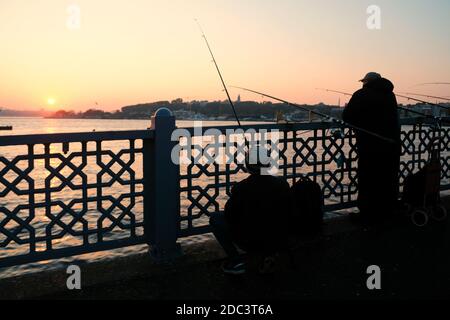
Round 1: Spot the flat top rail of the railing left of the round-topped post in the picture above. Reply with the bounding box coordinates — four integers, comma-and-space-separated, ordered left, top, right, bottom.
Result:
0, 130, 154, 146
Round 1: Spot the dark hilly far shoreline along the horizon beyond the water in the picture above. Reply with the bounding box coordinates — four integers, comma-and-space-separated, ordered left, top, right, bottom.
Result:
6, 99, 450, 121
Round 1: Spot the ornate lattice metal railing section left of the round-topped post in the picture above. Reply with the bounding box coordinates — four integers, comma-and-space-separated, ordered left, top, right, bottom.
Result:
0, 130, 153, 265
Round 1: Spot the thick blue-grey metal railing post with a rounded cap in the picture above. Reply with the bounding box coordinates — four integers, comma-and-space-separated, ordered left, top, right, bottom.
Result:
144, 108, 181, 261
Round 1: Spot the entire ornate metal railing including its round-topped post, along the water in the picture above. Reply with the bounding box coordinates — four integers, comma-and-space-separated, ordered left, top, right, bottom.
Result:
0, 110, 450, 267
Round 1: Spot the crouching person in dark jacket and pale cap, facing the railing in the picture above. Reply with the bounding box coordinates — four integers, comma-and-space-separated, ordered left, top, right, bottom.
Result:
210, 146, 292, 275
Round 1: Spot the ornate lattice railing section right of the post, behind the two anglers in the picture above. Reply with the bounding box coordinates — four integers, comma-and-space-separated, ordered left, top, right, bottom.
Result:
179, 118, 450, 236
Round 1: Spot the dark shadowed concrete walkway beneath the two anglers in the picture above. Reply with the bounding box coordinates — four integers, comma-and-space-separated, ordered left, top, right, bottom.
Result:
0, 198, 450, 300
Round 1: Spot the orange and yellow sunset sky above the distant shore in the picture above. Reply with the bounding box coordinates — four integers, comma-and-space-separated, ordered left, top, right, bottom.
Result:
0, 0, 450, 110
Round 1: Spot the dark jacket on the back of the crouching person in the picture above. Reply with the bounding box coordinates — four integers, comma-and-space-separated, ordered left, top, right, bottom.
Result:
225, 175, 292, 251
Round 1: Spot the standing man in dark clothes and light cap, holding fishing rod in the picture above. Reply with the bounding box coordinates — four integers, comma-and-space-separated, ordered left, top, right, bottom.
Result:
343, 72, 401, 221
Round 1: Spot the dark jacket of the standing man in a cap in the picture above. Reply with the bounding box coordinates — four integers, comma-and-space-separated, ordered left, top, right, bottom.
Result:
342, 78, 400, 153
